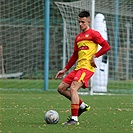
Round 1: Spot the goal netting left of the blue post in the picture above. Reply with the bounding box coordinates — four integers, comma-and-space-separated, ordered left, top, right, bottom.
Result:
0, 0, 44, 88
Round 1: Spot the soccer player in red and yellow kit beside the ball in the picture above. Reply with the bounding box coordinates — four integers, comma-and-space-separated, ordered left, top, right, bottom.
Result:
56, 11, 110, 125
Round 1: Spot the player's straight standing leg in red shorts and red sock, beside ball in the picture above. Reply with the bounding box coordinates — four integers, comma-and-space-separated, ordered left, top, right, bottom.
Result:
64, 69, 90, 125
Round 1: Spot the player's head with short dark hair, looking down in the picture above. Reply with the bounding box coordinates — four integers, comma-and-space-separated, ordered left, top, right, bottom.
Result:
78, 11, 90, 31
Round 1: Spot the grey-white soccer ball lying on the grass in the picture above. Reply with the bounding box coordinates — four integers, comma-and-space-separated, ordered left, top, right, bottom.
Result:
44, 110, 59, 124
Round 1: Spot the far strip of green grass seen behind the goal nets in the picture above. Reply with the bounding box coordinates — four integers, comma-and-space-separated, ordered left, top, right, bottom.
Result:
0, 79, 133, 93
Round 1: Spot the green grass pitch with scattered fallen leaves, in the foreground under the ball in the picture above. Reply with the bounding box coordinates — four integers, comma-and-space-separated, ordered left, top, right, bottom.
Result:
0, 79, 133, 133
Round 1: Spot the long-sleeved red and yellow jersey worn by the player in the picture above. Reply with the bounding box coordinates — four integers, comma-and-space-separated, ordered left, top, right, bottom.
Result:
66, 28, 110, 72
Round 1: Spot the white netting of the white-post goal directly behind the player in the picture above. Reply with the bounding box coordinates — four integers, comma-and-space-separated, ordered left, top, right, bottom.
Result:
55, 0, 133, 91
